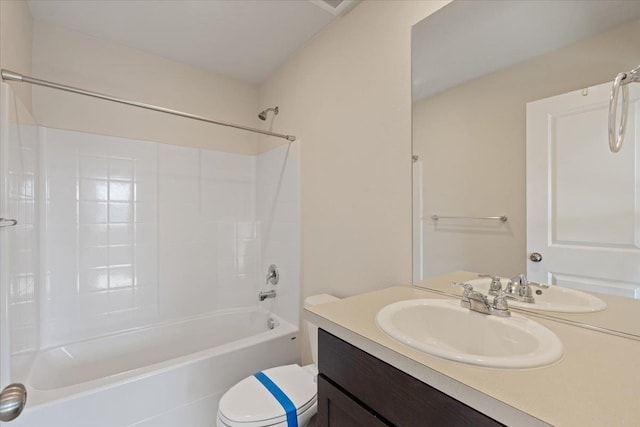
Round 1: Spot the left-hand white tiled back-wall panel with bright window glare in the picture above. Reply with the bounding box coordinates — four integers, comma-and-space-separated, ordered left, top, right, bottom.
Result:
41, 128, 158, 347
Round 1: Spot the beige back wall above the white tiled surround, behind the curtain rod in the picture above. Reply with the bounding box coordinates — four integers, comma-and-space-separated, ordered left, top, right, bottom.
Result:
30, 21, 259, 154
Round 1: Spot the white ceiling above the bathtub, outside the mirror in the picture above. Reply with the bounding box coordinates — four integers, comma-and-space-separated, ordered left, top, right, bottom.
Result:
28, 0, 355, 83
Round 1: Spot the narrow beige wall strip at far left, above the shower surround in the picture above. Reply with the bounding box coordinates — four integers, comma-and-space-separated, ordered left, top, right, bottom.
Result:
0, 0, 33, 110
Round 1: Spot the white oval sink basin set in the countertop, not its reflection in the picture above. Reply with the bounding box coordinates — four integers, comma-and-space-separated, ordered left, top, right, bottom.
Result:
376, 299, 564, 368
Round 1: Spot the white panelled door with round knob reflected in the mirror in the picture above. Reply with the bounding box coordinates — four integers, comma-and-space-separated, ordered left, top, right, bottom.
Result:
527, 83, 640, 298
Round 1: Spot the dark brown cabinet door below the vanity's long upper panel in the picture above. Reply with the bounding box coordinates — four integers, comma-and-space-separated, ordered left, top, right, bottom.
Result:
317, 375, 389, 427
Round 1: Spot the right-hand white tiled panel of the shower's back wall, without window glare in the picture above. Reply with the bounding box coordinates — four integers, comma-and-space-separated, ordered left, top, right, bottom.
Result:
159, 145, 259, 318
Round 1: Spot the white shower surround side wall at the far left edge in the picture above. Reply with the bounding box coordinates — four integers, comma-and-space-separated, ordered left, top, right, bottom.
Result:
0, 83, 39, 387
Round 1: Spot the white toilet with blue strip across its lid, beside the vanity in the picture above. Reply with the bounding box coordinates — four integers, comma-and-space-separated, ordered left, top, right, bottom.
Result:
217, 294, 338, 427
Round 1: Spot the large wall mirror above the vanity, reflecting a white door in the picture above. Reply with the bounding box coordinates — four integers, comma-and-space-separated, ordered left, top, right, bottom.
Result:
412, 0, 640, 338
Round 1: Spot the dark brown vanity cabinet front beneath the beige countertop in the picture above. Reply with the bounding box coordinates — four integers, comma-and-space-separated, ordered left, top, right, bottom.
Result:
318, 329, 502, 427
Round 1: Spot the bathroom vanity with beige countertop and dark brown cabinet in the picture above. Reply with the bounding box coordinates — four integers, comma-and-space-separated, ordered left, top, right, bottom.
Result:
305, 273, 640, 426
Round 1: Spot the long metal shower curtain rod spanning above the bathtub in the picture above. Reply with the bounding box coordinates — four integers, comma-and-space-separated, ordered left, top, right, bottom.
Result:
0, 70, 296, 142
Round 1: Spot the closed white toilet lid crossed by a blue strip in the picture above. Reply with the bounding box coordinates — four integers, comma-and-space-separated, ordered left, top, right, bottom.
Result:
218, 365, 318, 427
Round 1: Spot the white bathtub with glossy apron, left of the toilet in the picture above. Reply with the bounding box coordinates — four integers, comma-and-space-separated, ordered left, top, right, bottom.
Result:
11, 308, 299, 427
